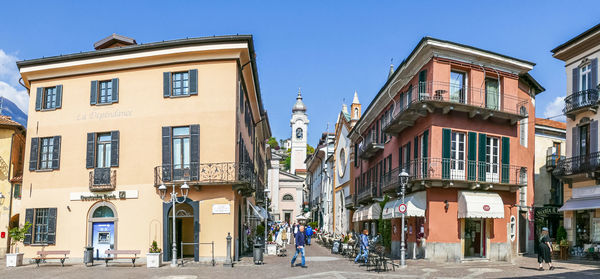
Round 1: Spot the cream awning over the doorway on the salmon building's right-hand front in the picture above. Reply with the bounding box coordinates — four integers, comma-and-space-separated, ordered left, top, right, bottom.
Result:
458, 191, 504, 219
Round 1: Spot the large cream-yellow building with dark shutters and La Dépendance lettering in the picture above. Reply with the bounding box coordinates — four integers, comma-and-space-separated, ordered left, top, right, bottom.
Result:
17, 34, 270, 261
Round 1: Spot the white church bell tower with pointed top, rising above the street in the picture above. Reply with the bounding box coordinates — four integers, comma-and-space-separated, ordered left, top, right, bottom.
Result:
290, 89, 308, 174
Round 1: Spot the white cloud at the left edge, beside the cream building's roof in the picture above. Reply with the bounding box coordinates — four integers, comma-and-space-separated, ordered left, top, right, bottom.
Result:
0, 49, 29, 114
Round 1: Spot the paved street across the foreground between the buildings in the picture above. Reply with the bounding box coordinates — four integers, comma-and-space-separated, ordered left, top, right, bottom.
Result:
0, 245, 600, 279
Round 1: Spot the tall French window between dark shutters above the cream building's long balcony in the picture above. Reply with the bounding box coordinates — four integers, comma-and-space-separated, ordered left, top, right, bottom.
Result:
173, 126, 190, 180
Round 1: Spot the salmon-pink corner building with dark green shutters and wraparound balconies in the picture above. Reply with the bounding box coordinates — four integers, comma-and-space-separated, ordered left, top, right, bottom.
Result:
349, 37, 544, 262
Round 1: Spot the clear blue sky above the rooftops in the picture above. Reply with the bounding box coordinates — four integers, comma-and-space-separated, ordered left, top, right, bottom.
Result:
0, 1, 600, 145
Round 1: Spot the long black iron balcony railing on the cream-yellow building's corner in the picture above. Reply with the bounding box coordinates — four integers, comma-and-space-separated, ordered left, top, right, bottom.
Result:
154, 162, 257, 187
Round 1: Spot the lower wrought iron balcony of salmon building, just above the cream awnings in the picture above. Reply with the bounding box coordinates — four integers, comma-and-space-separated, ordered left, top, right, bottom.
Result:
405, 158, 527, 186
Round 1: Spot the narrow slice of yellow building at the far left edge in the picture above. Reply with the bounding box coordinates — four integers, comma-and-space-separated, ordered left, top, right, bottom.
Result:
0, 115, 25, 257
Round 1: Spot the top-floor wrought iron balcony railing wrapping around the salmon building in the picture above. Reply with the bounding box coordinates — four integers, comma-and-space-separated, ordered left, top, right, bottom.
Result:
382, 81, 529, 133
